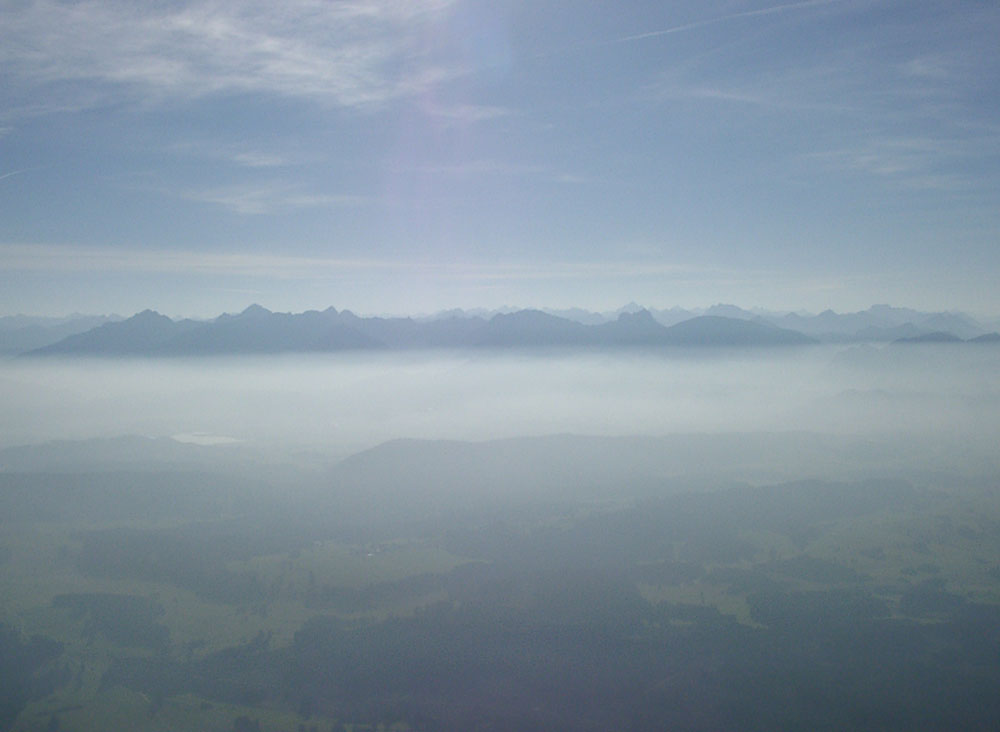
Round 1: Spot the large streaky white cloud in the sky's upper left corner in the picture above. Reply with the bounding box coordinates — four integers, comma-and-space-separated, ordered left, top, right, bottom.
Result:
0, 0, 457, 108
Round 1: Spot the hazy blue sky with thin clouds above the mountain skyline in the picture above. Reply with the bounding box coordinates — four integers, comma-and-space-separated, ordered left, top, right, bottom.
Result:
0, 0, 1000, 317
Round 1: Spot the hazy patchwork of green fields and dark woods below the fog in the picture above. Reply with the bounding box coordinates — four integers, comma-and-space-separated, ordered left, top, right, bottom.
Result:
0, 438, 1000, 732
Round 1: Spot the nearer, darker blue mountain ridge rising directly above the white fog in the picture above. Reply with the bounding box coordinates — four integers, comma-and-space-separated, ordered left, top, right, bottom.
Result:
25, 305, 814, 355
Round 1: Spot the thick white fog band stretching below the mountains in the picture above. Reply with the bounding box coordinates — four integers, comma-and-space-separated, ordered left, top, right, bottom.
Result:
0, 344, 1000, 455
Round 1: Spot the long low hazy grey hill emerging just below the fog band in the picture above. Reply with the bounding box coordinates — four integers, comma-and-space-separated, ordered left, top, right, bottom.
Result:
324, 432, 940, 523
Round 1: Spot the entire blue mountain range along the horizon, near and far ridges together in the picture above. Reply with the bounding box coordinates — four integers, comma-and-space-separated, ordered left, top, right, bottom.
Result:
13, 303, 1000, 356
